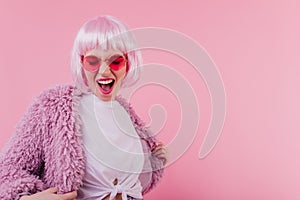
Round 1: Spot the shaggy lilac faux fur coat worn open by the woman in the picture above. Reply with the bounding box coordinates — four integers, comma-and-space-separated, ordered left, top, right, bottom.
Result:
0, 85, 163, 200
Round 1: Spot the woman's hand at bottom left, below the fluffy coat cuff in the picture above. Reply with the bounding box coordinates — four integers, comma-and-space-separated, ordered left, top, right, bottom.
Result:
20, 188, 77, 200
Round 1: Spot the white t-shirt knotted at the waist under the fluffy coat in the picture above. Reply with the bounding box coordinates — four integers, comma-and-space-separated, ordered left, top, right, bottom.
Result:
77, 94, 144, 200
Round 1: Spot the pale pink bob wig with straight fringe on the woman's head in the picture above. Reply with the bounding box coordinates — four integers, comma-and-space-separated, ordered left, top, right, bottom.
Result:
71, 15, 142, 92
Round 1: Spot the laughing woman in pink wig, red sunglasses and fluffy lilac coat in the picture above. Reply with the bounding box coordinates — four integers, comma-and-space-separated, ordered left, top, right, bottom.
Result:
0, 16, 166, 200
